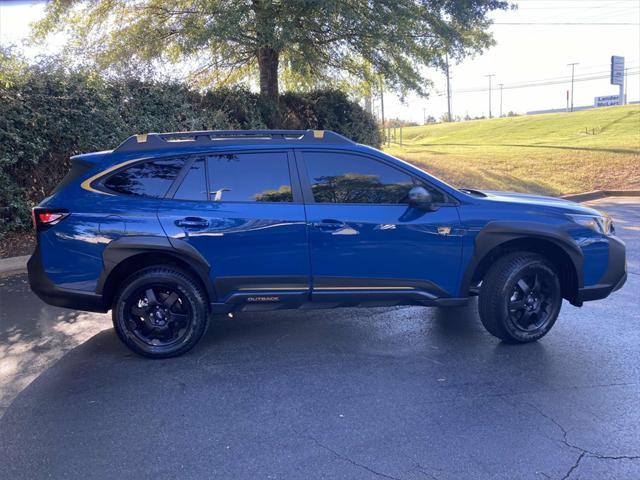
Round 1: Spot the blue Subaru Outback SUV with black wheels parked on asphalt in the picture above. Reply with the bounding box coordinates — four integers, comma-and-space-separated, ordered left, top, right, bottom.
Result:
29, 130, 626, 357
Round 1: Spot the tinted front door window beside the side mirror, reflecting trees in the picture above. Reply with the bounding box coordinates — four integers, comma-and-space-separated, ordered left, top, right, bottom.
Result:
304, 152, 414, 203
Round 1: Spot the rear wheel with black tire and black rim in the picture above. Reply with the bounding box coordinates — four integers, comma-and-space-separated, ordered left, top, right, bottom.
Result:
112, 266, 208, 358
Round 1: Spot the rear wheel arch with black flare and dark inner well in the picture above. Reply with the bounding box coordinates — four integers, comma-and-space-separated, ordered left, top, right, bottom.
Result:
96, 236, 216, 308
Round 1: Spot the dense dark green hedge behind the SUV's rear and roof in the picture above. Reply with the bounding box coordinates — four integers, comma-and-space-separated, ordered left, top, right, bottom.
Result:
0, 57, 380, 238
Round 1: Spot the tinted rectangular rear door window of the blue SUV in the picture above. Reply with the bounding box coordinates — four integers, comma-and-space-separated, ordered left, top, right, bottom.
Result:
207, 152, 293, 202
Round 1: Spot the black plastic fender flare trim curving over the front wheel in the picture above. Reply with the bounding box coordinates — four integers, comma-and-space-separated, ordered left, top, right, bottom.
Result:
460, 221, 584, 296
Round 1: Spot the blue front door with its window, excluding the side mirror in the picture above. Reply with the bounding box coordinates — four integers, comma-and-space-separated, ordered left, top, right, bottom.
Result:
298, 150, 462, 299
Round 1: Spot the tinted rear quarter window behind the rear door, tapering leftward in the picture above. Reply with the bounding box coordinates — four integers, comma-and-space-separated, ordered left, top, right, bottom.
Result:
103, 158, 184, 197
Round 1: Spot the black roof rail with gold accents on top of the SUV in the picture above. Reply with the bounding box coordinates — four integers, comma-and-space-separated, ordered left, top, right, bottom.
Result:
114, 130, 355, 153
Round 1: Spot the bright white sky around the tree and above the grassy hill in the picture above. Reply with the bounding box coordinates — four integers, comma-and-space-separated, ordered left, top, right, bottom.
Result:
0, 0, 640, 123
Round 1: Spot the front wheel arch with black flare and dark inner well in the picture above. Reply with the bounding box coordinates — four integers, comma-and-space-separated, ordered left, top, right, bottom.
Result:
461, 222, 583, 306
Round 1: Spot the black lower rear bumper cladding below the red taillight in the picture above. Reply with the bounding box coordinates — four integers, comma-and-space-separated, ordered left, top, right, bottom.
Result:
27, 245, 108, 313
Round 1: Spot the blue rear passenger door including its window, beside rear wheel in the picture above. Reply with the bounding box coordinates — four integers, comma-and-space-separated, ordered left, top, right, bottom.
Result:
159, 149, 309, 303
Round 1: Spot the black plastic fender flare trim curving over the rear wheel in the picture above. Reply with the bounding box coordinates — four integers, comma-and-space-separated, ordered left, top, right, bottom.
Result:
96, 235, 216, 302
